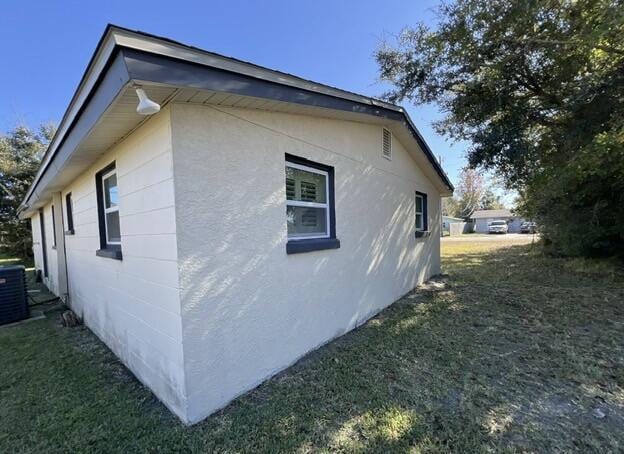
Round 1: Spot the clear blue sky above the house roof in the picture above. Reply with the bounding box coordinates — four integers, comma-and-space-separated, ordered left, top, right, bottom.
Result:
0, 0, 466, 186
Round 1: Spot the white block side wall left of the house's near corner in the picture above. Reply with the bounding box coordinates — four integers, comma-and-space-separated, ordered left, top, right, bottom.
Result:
32, 110, 186, 418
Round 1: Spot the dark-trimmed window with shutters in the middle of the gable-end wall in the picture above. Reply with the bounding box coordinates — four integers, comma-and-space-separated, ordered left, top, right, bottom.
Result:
285, 154, 340, 254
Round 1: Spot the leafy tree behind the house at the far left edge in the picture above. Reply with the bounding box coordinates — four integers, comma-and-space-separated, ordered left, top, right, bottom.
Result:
0, 125, 55, 257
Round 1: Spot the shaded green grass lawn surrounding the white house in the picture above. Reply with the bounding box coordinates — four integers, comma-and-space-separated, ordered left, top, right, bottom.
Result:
0, 241, 624, 452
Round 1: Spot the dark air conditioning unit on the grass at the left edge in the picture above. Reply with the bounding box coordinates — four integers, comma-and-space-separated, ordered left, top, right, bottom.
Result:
0, 265, 29, 325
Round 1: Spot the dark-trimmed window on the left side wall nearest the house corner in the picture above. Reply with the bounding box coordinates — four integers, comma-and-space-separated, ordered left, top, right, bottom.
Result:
95, 162, 122, 260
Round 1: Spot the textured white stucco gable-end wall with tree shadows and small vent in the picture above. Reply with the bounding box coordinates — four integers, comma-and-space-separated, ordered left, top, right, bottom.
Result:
172, 104, 440, 422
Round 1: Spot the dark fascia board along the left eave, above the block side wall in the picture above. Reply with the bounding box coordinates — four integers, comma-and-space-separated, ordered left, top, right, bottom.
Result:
20, 50, 130, 216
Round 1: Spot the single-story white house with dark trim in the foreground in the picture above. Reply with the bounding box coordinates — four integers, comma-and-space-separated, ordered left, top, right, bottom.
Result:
20, 26, 453, 423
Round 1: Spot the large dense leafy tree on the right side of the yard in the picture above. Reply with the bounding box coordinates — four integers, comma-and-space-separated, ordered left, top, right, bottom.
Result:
376, 0, 624, 254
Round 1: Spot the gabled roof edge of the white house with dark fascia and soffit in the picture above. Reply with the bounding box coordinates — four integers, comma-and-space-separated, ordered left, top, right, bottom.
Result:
20, 25, 453, 217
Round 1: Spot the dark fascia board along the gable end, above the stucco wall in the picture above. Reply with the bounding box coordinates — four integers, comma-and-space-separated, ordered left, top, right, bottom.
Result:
123, 49, 453, 191
